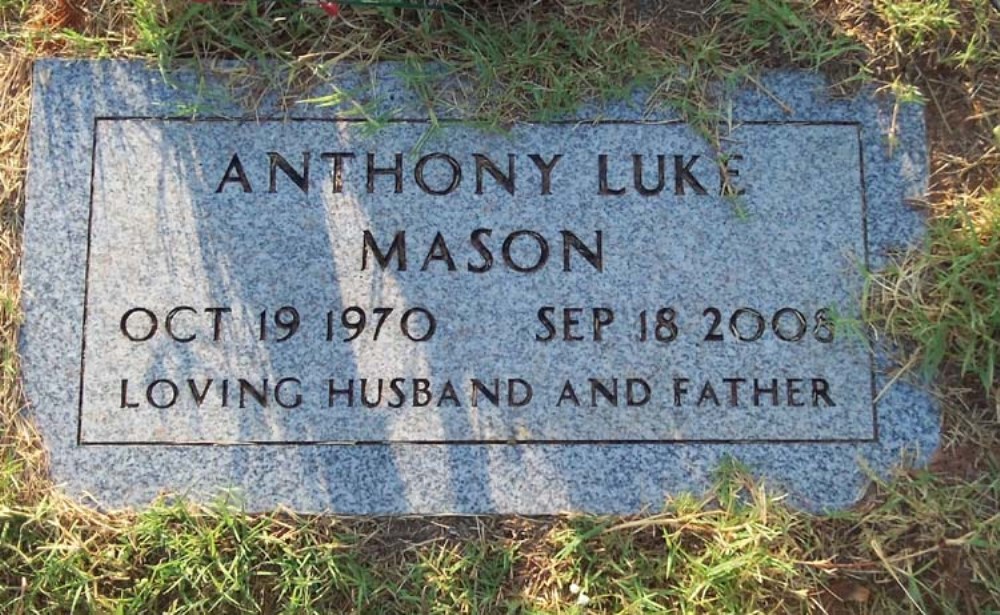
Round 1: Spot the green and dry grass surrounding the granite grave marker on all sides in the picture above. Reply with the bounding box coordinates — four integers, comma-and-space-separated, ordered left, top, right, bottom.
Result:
0, 0, 1000, 613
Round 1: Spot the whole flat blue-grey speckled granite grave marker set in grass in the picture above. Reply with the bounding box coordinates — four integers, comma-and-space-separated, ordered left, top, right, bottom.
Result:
21, 61, 939, 514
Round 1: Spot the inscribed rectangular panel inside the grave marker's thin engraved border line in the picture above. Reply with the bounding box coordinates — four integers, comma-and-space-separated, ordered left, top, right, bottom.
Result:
80, 119, 875, 444
